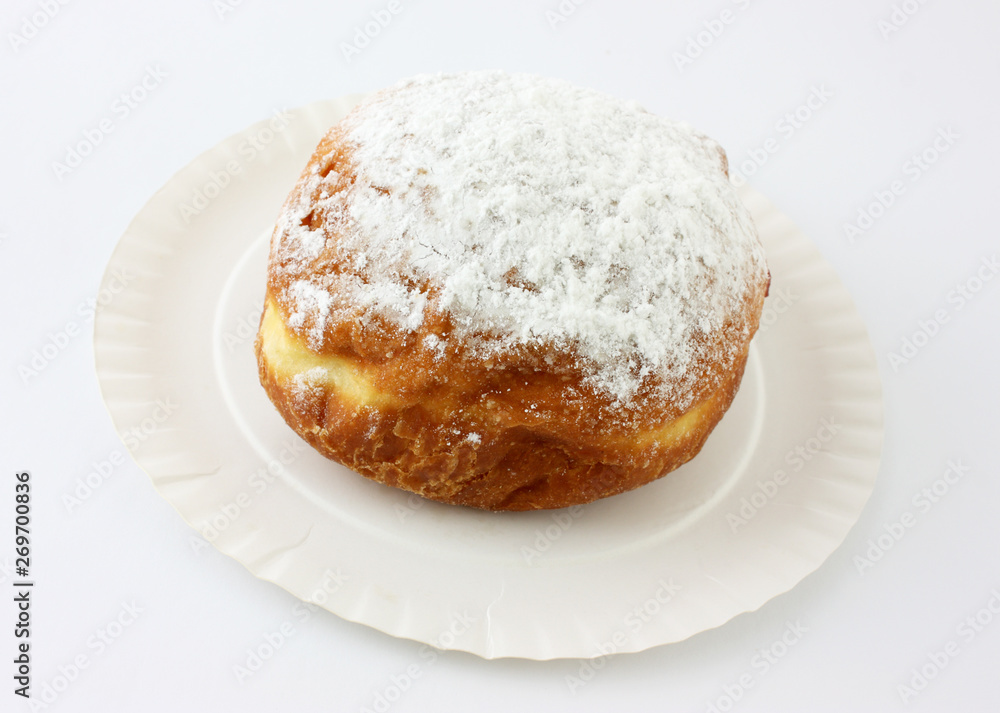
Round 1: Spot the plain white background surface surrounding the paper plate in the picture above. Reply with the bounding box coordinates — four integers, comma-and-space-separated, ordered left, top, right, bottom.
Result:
0, 0, 1000, 711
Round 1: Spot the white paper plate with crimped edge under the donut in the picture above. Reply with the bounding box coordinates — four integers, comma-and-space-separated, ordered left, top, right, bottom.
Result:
94, 97, 882, 659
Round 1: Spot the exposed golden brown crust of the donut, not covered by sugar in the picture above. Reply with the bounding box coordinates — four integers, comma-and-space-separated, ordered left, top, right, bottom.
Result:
255, 80, 770, 510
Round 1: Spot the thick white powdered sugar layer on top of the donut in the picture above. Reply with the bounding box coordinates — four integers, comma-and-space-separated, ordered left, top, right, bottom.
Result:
278, 72, 766, 402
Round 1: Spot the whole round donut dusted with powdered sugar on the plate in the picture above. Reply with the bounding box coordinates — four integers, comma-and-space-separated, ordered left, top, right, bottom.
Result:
255, 71, 770, 510
